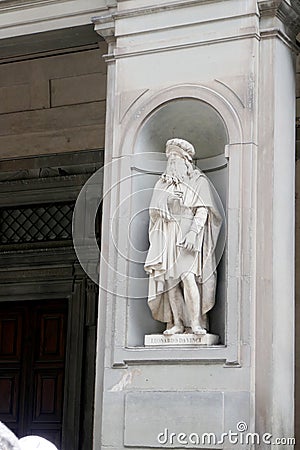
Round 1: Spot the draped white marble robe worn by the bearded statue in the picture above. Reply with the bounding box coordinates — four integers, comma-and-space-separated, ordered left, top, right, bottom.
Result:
145, 170, 222, 327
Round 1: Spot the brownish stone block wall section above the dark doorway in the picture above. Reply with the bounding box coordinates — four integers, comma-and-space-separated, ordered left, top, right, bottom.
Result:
0, 43, 106, 159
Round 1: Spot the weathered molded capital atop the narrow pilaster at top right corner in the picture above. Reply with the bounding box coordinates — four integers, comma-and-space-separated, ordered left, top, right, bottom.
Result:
258, 0, 300, 37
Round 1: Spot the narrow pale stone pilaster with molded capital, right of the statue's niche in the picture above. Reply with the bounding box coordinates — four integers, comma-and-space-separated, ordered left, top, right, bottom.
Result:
255, 1, 300, 448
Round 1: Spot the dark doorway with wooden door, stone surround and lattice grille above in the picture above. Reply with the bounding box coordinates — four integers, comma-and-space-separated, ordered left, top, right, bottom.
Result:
0, 150, 103, 450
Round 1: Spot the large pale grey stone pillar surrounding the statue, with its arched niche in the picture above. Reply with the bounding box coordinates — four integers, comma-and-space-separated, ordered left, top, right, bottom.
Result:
94, 0, 298, 450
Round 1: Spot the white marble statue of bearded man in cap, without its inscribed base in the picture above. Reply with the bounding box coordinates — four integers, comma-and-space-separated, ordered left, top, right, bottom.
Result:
144, 138, 222, 336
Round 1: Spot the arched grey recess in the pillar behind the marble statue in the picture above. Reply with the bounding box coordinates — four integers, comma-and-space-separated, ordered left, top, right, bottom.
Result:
127, 97, 229, 347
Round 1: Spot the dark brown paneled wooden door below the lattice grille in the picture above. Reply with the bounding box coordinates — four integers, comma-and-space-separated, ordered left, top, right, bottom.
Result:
0, 300, 67, 447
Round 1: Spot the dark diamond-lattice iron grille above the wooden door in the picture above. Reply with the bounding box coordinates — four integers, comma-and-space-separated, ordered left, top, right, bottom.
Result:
0, 203, 74, 245
